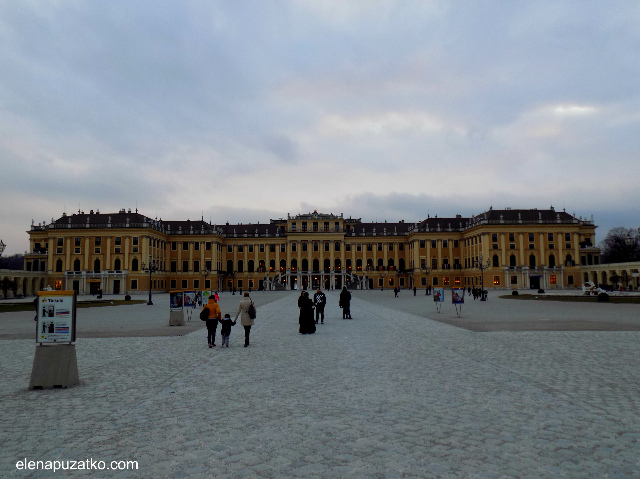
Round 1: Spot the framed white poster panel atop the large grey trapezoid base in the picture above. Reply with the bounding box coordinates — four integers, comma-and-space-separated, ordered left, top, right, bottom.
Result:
36, 291, 76, 344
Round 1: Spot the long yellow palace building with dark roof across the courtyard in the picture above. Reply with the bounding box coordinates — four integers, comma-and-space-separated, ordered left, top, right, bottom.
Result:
25, 208, 600, 294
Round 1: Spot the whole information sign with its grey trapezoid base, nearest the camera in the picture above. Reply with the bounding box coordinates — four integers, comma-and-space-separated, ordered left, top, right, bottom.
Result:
29, 291, 80, 389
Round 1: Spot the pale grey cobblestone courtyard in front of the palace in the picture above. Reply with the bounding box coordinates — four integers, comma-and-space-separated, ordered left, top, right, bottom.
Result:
0, 291, 640, 478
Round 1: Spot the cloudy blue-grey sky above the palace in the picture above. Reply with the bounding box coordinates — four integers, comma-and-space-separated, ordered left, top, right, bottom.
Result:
0, 0, 640, 255
